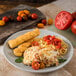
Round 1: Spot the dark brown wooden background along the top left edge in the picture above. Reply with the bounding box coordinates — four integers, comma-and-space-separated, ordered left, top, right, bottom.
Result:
0, 0, 55, 14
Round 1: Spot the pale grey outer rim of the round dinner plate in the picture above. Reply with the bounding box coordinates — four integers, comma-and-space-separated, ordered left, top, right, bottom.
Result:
3, 29, 74, 73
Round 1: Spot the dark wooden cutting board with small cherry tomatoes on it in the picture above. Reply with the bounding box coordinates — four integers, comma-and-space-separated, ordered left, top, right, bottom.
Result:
0, 5, 45, 44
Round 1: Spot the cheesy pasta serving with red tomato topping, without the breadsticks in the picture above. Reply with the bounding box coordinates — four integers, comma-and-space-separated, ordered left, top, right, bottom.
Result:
23, 35, 68, 70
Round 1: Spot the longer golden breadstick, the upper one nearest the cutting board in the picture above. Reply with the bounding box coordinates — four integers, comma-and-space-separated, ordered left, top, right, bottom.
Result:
8, 28, 40, 48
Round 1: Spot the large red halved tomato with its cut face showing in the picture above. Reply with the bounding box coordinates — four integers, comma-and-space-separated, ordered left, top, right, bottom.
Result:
55, 11, 73, 30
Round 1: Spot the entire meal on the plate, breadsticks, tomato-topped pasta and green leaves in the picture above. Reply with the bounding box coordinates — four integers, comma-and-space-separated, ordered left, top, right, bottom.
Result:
8, 28, 68, 70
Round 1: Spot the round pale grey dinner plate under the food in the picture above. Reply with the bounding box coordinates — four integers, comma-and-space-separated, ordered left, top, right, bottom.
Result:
3, 29, 73, 73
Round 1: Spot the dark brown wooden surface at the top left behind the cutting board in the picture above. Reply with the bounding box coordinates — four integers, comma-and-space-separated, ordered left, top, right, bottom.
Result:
0, 0, 55, 14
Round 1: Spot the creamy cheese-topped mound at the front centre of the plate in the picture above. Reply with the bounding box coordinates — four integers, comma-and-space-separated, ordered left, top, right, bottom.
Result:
23, 46, 59, 67
